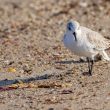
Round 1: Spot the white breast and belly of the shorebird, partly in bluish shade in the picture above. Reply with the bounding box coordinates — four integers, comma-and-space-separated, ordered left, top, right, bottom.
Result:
63, 33, 94, 57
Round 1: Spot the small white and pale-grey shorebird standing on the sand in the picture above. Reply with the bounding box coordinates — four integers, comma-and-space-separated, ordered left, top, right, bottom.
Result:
63, 20, 110, 75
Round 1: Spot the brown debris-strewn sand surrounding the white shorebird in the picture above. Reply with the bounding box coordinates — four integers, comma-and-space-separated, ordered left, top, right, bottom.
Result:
0, 0, 110, 110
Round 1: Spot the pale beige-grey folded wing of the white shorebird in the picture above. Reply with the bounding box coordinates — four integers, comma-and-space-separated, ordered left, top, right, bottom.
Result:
82, 27, 110, 50
